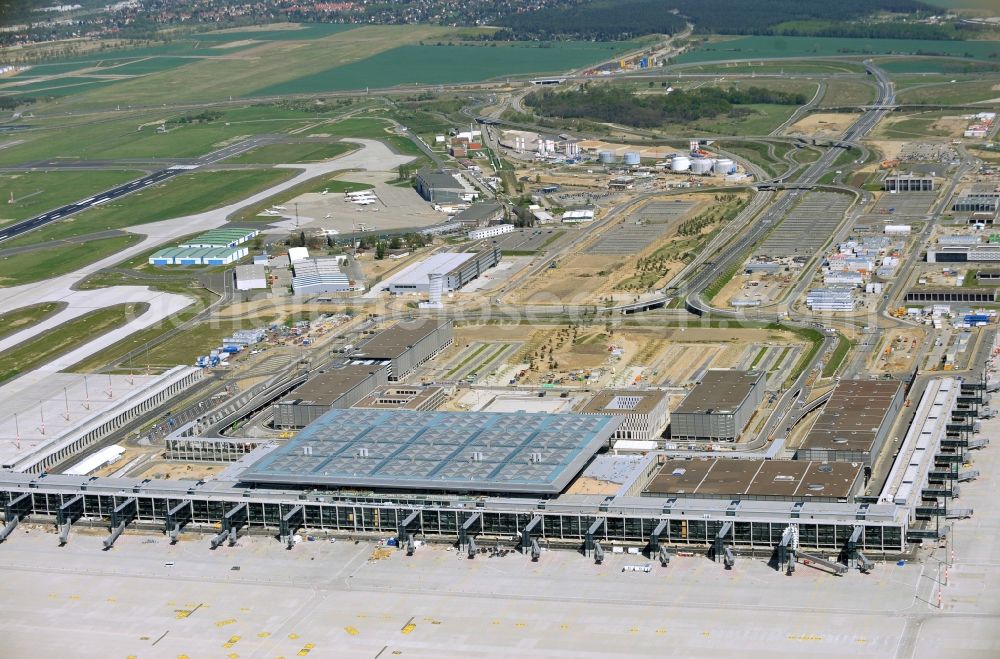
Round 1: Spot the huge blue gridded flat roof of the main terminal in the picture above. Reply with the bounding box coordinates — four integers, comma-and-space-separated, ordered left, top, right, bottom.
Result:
240, 409, 622, 494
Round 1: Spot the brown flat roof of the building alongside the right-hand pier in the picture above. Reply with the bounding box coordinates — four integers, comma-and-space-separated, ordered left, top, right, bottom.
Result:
802, 382, 904, 451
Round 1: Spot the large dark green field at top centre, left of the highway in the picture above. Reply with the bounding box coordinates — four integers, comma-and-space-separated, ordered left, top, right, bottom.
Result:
257, 41, 636, 94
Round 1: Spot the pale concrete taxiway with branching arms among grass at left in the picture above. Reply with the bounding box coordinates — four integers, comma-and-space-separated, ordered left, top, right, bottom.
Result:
0, 140, 411, 371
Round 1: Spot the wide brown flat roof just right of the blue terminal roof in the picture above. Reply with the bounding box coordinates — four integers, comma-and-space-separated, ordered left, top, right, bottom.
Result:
645, 458, 863, 500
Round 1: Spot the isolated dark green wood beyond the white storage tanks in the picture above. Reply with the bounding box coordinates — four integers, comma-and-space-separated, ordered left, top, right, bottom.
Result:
524, 84, 808, 128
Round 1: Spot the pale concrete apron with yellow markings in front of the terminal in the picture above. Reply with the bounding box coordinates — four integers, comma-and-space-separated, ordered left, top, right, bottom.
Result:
0, 446, 1000, 658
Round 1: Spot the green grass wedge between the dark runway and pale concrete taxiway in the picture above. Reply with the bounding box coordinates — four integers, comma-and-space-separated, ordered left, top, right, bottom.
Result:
4, 169, 296, 250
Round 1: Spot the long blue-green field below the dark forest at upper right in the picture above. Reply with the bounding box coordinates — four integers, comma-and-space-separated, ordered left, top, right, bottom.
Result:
676, 36, 997, 63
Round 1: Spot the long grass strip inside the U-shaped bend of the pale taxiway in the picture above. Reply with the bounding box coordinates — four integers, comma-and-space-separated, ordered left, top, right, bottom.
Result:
0, 304, 146, 382
